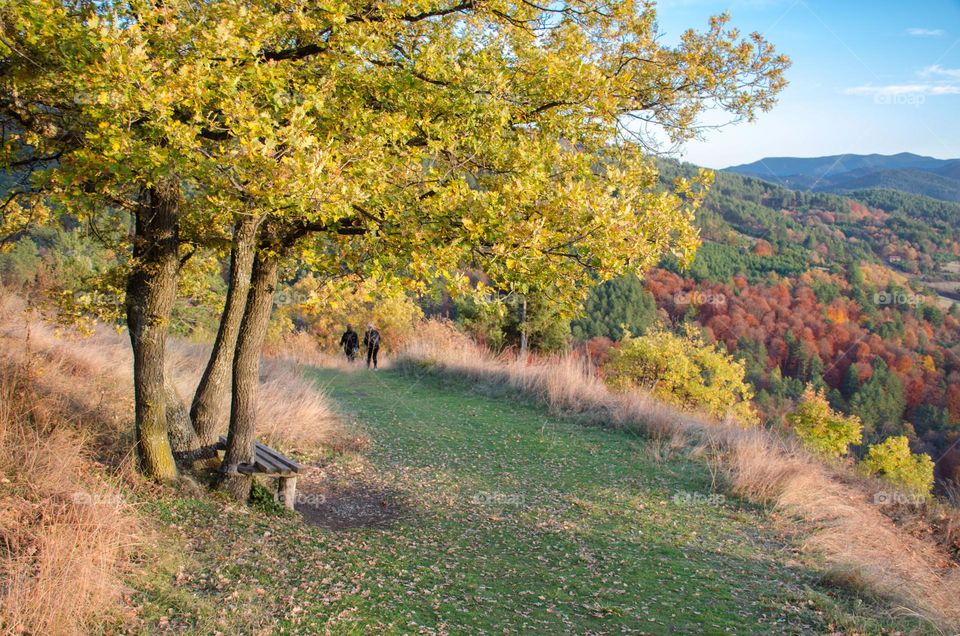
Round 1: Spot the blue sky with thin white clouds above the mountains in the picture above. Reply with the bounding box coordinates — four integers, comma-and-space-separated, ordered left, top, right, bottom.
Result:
657, 0, 960, 168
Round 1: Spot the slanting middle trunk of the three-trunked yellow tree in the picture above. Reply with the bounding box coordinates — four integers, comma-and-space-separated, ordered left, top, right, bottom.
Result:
190, 216, 259, 445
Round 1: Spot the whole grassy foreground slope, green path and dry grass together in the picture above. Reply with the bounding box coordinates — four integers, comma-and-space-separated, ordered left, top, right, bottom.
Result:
0, 296, 952, 634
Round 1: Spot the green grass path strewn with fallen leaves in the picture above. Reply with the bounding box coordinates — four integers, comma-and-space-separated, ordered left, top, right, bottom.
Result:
125, 370, 928, 634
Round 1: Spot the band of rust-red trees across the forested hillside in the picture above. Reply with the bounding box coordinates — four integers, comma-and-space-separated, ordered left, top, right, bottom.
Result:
646, 268, 960, 438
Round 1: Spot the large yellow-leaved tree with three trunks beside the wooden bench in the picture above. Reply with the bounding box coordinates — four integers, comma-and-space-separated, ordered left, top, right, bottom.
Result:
0, 0, 788, 478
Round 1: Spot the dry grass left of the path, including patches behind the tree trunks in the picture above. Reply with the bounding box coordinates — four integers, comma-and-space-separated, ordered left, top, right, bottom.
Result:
0, 290, 362, 634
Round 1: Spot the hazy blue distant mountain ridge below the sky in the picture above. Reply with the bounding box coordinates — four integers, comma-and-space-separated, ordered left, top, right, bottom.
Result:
726, 152, 960, 201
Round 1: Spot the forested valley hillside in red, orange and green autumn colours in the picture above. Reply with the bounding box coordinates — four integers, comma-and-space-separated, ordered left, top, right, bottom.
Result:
574, 162, 960, 486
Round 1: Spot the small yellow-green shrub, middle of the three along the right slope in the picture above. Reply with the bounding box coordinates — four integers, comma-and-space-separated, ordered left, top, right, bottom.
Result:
787, 385, 863, 459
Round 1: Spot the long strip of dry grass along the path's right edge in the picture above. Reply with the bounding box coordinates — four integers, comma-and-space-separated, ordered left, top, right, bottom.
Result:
398, 321, 960, 633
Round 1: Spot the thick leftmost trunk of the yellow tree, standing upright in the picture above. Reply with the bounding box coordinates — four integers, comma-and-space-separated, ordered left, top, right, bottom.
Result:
126, 180, 180, 480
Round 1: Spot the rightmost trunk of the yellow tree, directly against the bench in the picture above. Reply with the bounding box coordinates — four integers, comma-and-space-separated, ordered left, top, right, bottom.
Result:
221, 252, 280, 501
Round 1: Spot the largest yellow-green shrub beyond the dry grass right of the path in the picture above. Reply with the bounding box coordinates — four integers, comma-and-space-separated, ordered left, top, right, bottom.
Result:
604, 329, 759, 424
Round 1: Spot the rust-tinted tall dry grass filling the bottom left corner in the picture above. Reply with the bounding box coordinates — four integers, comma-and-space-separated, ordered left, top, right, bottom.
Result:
0, 301, 144, 634
